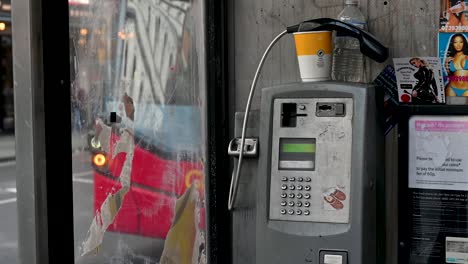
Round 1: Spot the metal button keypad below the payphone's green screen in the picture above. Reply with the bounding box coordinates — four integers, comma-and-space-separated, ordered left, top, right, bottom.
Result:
280, 176, 312, 216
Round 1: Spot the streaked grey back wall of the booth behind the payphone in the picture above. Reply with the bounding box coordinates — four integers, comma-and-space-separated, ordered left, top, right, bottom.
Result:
228, 0, 440, 263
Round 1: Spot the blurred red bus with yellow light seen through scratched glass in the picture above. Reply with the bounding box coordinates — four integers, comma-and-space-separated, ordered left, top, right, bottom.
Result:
90, 105, 205, 239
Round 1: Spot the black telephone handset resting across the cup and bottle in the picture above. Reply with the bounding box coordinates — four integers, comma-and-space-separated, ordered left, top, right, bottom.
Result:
287, 18, 389, 62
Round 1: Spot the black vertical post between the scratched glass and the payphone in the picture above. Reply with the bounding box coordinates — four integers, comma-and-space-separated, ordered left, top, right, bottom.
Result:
205, 0, 232, 264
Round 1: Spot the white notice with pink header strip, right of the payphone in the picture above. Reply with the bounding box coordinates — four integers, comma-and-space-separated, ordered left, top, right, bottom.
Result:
408, 116, 468, 191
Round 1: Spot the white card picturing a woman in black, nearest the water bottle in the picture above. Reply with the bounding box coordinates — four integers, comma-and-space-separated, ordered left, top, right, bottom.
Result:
393, 57, 444, 104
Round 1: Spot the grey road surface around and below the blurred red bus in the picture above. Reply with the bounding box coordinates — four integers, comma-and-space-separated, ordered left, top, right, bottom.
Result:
0, 135, 164, 264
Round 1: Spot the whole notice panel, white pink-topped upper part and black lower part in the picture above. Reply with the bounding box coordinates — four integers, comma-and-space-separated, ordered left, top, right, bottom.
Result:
406, 116, 468, 264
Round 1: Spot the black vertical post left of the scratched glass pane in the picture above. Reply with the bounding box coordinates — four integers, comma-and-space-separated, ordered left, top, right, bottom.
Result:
41, 0, 75, 264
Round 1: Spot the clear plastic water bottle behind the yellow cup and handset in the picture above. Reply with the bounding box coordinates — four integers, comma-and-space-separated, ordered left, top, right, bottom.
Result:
332, 0, 367, 82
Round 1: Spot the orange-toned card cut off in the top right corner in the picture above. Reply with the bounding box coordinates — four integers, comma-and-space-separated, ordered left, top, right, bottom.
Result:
439, 0, 468, 32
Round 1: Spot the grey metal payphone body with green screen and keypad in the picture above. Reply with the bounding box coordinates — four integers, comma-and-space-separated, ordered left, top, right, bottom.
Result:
256, 82, 383, 264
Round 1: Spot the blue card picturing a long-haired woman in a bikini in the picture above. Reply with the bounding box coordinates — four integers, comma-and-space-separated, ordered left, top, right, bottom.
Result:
439, 33, 468, 96
